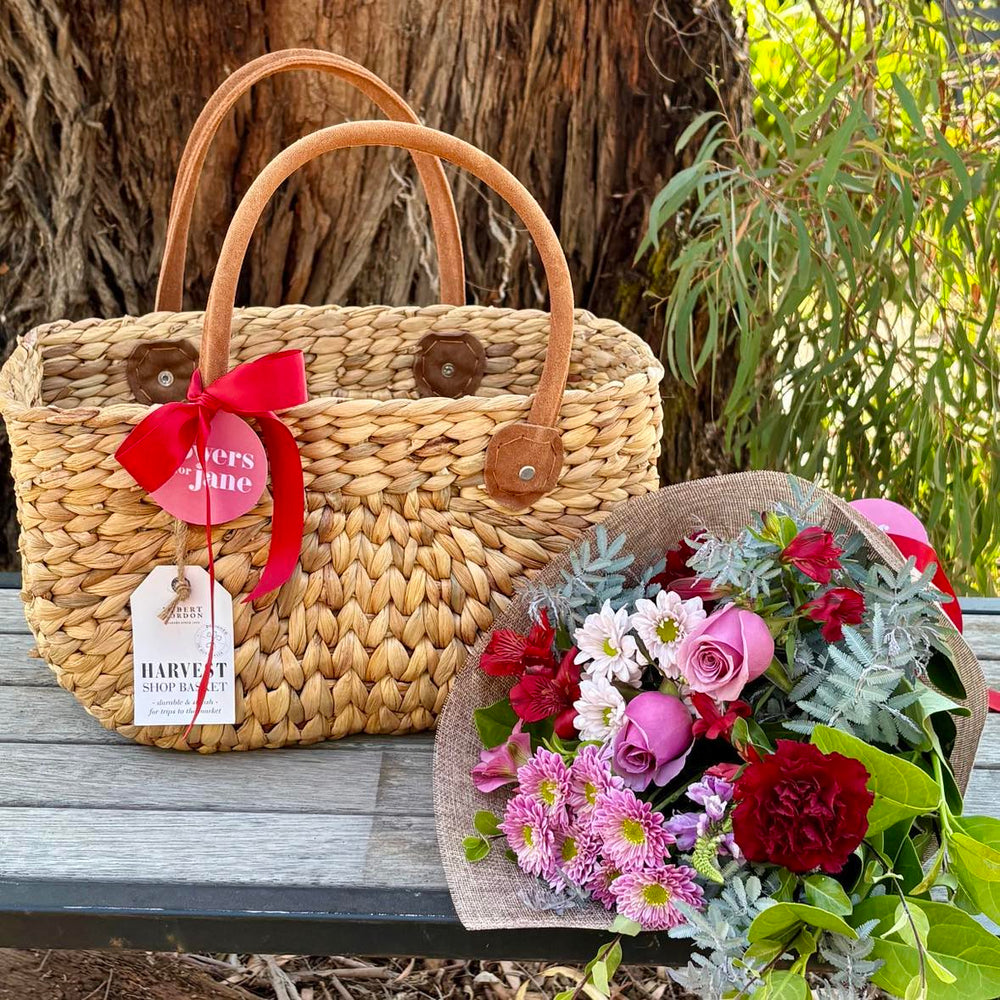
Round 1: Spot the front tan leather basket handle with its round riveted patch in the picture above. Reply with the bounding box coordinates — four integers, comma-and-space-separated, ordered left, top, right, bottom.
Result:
201, 121, 573, 508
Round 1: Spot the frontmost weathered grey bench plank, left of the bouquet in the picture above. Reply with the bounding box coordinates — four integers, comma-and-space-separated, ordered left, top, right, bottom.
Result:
0, 808, 445, 889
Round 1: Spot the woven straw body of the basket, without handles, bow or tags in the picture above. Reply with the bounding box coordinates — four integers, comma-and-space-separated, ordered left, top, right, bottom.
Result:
0, 306, 662, 750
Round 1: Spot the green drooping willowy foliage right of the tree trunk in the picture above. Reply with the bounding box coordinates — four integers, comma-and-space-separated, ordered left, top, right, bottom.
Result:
640, 0, 1000, 593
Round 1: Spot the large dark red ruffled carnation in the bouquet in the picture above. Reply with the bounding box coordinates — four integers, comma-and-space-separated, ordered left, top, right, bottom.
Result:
733, 740, 875, 874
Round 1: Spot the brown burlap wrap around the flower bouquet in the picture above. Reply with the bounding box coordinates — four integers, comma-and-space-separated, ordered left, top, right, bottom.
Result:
434, 472, 986, 930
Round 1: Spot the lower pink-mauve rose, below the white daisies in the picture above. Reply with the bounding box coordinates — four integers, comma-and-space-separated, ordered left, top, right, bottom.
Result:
614, 691, 694, 792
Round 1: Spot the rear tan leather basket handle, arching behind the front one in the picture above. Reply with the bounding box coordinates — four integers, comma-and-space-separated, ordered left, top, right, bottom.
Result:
156, 49, 465, 312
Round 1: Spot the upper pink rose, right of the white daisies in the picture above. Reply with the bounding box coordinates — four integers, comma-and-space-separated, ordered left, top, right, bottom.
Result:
677, 604, 774, 701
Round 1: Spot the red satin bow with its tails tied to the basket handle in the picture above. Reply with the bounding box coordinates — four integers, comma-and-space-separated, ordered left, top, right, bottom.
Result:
115, 351, 309, 736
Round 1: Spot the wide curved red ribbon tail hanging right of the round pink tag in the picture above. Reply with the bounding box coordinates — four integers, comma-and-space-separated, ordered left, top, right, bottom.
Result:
243, 413, 305, 603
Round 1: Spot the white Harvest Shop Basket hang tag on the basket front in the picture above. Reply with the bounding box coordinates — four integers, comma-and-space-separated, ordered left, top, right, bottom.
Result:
131, 566, 236, 726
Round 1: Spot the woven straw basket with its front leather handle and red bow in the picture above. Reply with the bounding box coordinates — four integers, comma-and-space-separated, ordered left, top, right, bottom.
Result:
0, 109, 662, 751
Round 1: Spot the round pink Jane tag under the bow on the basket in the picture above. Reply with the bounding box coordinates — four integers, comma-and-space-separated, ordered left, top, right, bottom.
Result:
152, 411, 267, 524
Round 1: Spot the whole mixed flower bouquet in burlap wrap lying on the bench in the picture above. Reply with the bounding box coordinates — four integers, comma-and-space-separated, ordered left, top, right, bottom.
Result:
434, 472, 1000, 1000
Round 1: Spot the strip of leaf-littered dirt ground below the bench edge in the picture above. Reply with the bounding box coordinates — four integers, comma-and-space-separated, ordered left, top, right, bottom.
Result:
0, 949, 682, 1000
